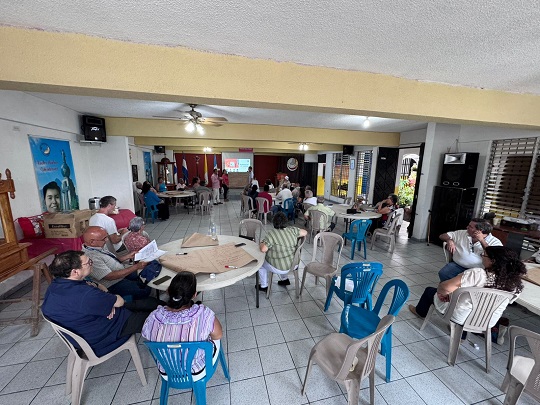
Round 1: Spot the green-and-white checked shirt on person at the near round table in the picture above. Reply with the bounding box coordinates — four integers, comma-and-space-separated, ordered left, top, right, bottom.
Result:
262, 226, 300, 270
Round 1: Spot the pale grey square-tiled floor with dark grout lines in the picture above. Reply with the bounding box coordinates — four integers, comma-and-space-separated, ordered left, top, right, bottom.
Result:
0, 201, 540, 405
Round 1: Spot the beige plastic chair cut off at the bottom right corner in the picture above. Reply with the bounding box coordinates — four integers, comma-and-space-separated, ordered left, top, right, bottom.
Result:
501, 326, 540, 405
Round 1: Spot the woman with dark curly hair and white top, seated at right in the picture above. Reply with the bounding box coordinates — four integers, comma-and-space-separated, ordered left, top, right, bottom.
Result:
409, 246, 527, 339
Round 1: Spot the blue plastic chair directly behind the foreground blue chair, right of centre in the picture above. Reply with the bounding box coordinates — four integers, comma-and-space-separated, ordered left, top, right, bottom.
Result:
324, 262, 382, 311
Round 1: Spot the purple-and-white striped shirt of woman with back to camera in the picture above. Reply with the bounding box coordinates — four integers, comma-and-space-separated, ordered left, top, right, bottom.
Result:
141, 304, 216, 373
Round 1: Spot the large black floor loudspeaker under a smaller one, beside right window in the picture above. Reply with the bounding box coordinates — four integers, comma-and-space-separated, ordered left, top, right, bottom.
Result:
429, 186, 478, 246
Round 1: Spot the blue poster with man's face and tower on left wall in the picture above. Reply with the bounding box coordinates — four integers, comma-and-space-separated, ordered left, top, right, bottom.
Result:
28, 135, 79, 213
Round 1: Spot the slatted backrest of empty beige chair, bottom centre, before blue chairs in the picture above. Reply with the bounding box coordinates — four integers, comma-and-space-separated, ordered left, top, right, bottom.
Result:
336, 315, 396, 381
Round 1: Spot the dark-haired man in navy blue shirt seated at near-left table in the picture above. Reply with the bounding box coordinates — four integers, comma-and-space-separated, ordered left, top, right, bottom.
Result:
41, 250, 159, 357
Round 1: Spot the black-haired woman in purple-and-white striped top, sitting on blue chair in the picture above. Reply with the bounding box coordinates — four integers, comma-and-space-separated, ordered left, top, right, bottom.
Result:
141, 271, 223, 379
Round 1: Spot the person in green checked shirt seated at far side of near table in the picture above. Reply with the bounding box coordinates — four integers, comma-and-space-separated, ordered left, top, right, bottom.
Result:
257, 212, 307, 291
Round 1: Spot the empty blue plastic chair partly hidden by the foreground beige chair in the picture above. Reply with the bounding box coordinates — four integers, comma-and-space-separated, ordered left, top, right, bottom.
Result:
339, 279, 409, 382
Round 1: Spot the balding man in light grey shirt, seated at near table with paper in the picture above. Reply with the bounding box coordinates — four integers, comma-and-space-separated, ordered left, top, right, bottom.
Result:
83, 226, 151, 299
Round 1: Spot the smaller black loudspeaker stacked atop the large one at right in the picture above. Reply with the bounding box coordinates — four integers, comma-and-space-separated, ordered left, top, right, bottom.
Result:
441, 152, 480, 188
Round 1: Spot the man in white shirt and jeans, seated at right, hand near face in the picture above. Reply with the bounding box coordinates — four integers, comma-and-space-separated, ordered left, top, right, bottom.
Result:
439, 218, 502, 281
